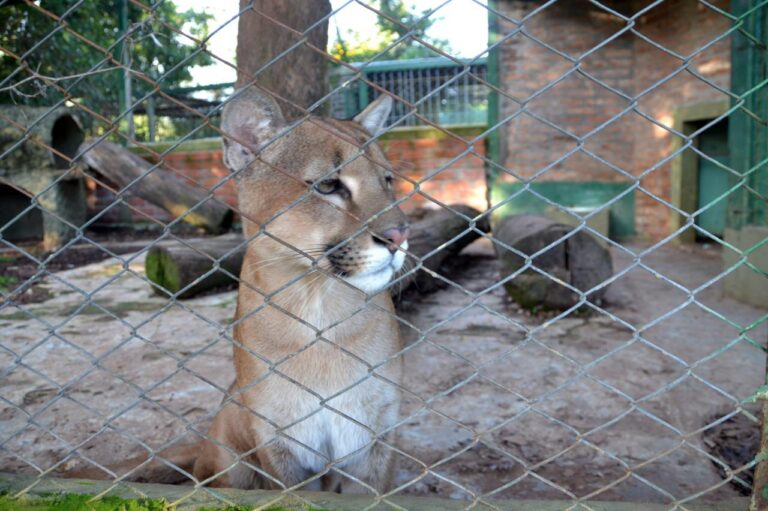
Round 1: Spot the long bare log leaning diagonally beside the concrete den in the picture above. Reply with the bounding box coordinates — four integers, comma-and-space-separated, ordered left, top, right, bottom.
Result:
80, 141, 234, 234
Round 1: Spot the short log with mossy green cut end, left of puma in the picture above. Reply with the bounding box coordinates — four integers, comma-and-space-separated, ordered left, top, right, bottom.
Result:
144, 233, 245, 298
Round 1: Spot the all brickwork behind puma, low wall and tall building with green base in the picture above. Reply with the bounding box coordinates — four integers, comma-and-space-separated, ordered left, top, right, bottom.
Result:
90, 0, 731, 244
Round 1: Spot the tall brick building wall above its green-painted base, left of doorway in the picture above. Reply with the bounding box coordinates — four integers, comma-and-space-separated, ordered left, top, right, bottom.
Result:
497, 0, 730, 238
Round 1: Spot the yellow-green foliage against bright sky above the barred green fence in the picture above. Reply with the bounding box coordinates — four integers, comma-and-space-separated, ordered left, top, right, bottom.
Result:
331, 0, 450, 62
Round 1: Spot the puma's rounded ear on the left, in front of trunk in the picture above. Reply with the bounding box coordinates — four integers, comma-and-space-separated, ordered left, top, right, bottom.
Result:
221, 86, 285, 172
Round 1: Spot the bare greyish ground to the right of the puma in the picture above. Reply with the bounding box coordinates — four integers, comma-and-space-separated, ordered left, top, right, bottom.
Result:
392, 241, 766, 502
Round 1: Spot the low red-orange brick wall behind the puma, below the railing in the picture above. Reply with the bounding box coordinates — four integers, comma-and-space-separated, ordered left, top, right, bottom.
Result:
88, 128, 487, 225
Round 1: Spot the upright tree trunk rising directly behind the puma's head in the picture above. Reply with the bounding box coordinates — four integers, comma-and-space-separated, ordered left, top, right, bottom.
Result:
237, 0, 331, 120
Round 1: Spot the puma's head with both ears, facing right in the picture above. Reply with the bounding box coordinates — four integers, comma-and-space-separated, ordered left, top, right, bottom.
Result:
222, 87, 408, 294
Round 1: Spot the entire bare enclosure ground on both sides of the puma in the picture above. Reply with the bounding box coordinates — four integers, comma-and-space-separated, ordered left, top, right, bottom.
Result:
0, 241, 768, 502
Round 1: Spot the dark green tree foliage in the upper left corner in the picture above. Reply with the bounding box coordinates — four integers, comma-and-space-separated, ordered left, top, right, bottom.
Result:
0, 0, 212, 118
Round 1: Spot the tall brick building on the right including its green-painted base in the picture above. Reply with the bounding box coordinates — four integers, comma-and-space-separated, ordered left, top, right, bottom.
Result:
489, 0, 731, 239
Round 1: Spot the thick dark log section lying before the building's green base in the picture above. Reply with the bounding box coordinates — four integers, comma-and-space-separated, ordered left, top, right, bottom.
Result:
493, 215, 613, 309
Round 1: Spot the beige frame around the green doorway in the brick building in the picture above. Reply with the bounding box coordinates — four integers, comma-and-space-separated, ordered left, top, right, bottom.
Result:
669, 100, 729, 243
